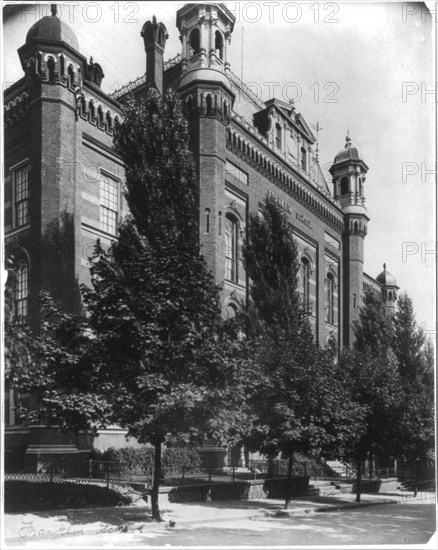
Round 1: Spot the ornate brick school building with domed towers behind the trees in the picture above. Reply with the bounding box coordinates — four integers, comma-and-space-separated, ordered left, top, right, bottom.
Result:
4, 3, 398, 468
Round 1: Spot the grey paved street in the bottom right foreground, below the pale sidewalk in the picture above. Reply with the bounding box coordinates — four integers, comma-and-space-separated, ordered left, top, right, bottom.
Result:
160, 504, 435, 547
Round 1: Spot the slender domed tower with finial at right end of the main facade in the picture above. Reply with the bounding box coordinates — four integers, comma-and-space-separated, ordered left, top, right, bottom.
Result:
330, 134, 369, 347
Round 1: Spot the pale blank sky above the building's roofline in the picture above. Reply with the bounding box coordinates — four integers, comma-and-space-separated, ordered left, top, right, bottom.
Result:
3, 1, 437, 338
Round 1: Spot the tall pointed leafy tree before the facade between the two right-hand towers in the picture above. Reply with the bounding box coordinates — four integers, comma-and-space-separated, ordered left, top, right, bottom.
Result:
243, 198, 355, 506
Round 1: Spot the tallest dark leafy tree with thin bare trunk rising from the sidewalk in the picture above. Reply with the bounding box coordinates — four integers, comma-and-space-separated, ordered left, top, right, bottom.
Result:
84, 91, 250, 520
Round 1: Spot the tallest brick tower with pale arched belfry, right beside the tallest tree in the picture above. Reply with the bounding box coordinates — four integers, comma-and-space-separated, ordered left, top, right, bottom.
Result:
176, 3, 235, 282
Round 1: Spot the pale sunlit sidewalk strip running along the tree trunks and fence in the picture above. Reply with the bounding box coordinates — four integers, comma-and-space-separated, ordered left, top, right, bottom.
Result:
5, 492, 435, 547
